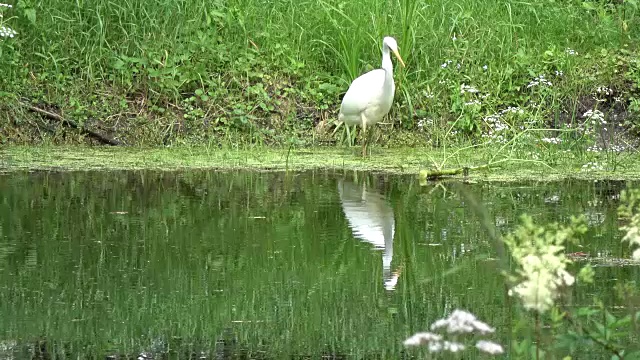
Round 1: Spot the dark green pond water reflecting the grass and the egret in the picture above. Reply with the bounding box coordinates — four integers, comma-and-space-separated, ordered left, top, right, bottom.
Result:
0, 171, 639, 359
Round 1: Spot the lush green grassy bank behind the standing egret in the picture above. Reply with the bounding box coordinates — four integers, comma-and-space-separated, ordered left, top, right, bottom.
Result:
0, 0, 640, 148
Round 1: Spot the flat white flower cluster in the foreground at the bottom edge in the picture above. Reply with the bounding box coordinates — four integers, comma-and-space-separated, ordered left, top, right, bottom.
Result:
404, 310, 504, 355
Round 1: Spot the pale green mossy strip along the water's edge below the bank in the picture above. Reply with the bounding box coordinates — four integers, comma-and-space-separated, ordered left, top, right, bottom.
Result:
5, 147, 640, 181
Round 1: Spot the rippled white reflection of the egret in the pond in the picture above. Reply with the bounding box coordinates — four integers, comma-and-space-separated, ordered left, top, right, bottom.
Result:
338, 180, 400, 290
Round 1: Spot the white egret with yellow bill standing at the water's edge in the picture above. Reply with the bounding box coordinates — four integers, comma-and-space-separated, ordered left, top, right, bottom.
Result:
338, 36, 405, 157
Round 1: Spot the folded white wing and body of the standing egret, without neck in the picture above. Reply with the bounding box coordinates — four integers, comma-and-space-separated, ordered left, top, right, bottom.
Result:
340, 69, 386, 121
